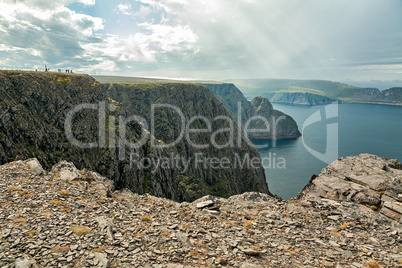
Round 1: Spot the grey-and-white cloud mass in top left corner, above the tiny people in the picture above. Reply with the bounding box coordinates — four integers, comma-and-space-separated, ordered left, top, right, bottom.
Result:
0, 0, 103, 66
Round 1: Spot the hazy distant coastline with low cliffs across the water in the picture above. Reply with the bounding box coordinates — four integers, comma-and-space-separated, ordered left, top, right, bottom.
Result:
226, 79, 402, 105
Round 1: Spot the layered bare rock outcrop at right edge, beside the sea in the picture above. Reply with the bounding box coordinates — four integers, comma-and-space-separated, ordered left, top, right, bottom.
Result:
297, 154, 402, 222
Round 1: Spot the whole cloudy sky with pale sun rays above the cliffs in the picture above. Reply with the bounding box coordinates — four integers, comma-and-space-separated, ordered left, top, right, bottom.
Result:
0, 0, 402, 81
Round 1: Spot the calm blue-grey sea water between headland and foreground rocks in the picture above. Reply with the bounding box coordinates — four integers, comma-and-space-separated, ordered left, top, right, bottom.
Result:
253, 104, 402, 199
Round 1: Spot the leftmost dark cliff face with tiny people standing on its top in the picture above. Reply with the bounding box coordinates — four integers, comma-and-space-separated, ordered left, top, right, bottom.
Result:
0, 71, 114, 175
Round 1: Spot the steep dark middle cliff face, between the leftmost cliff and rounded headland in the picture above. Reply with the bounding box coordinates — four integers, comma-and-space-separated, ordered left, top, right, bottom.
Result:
104, 83, 268, 199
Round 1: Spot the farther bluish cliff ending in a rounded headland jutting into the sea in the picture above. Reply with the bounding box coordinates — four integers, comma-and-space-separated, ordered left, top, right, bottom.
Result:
198, 83, 301, 139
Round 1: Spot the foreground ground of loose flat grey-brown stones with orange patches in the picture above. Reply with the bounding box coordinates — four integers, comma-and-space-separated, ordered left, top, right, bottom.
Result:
0, 156, 402, 268
